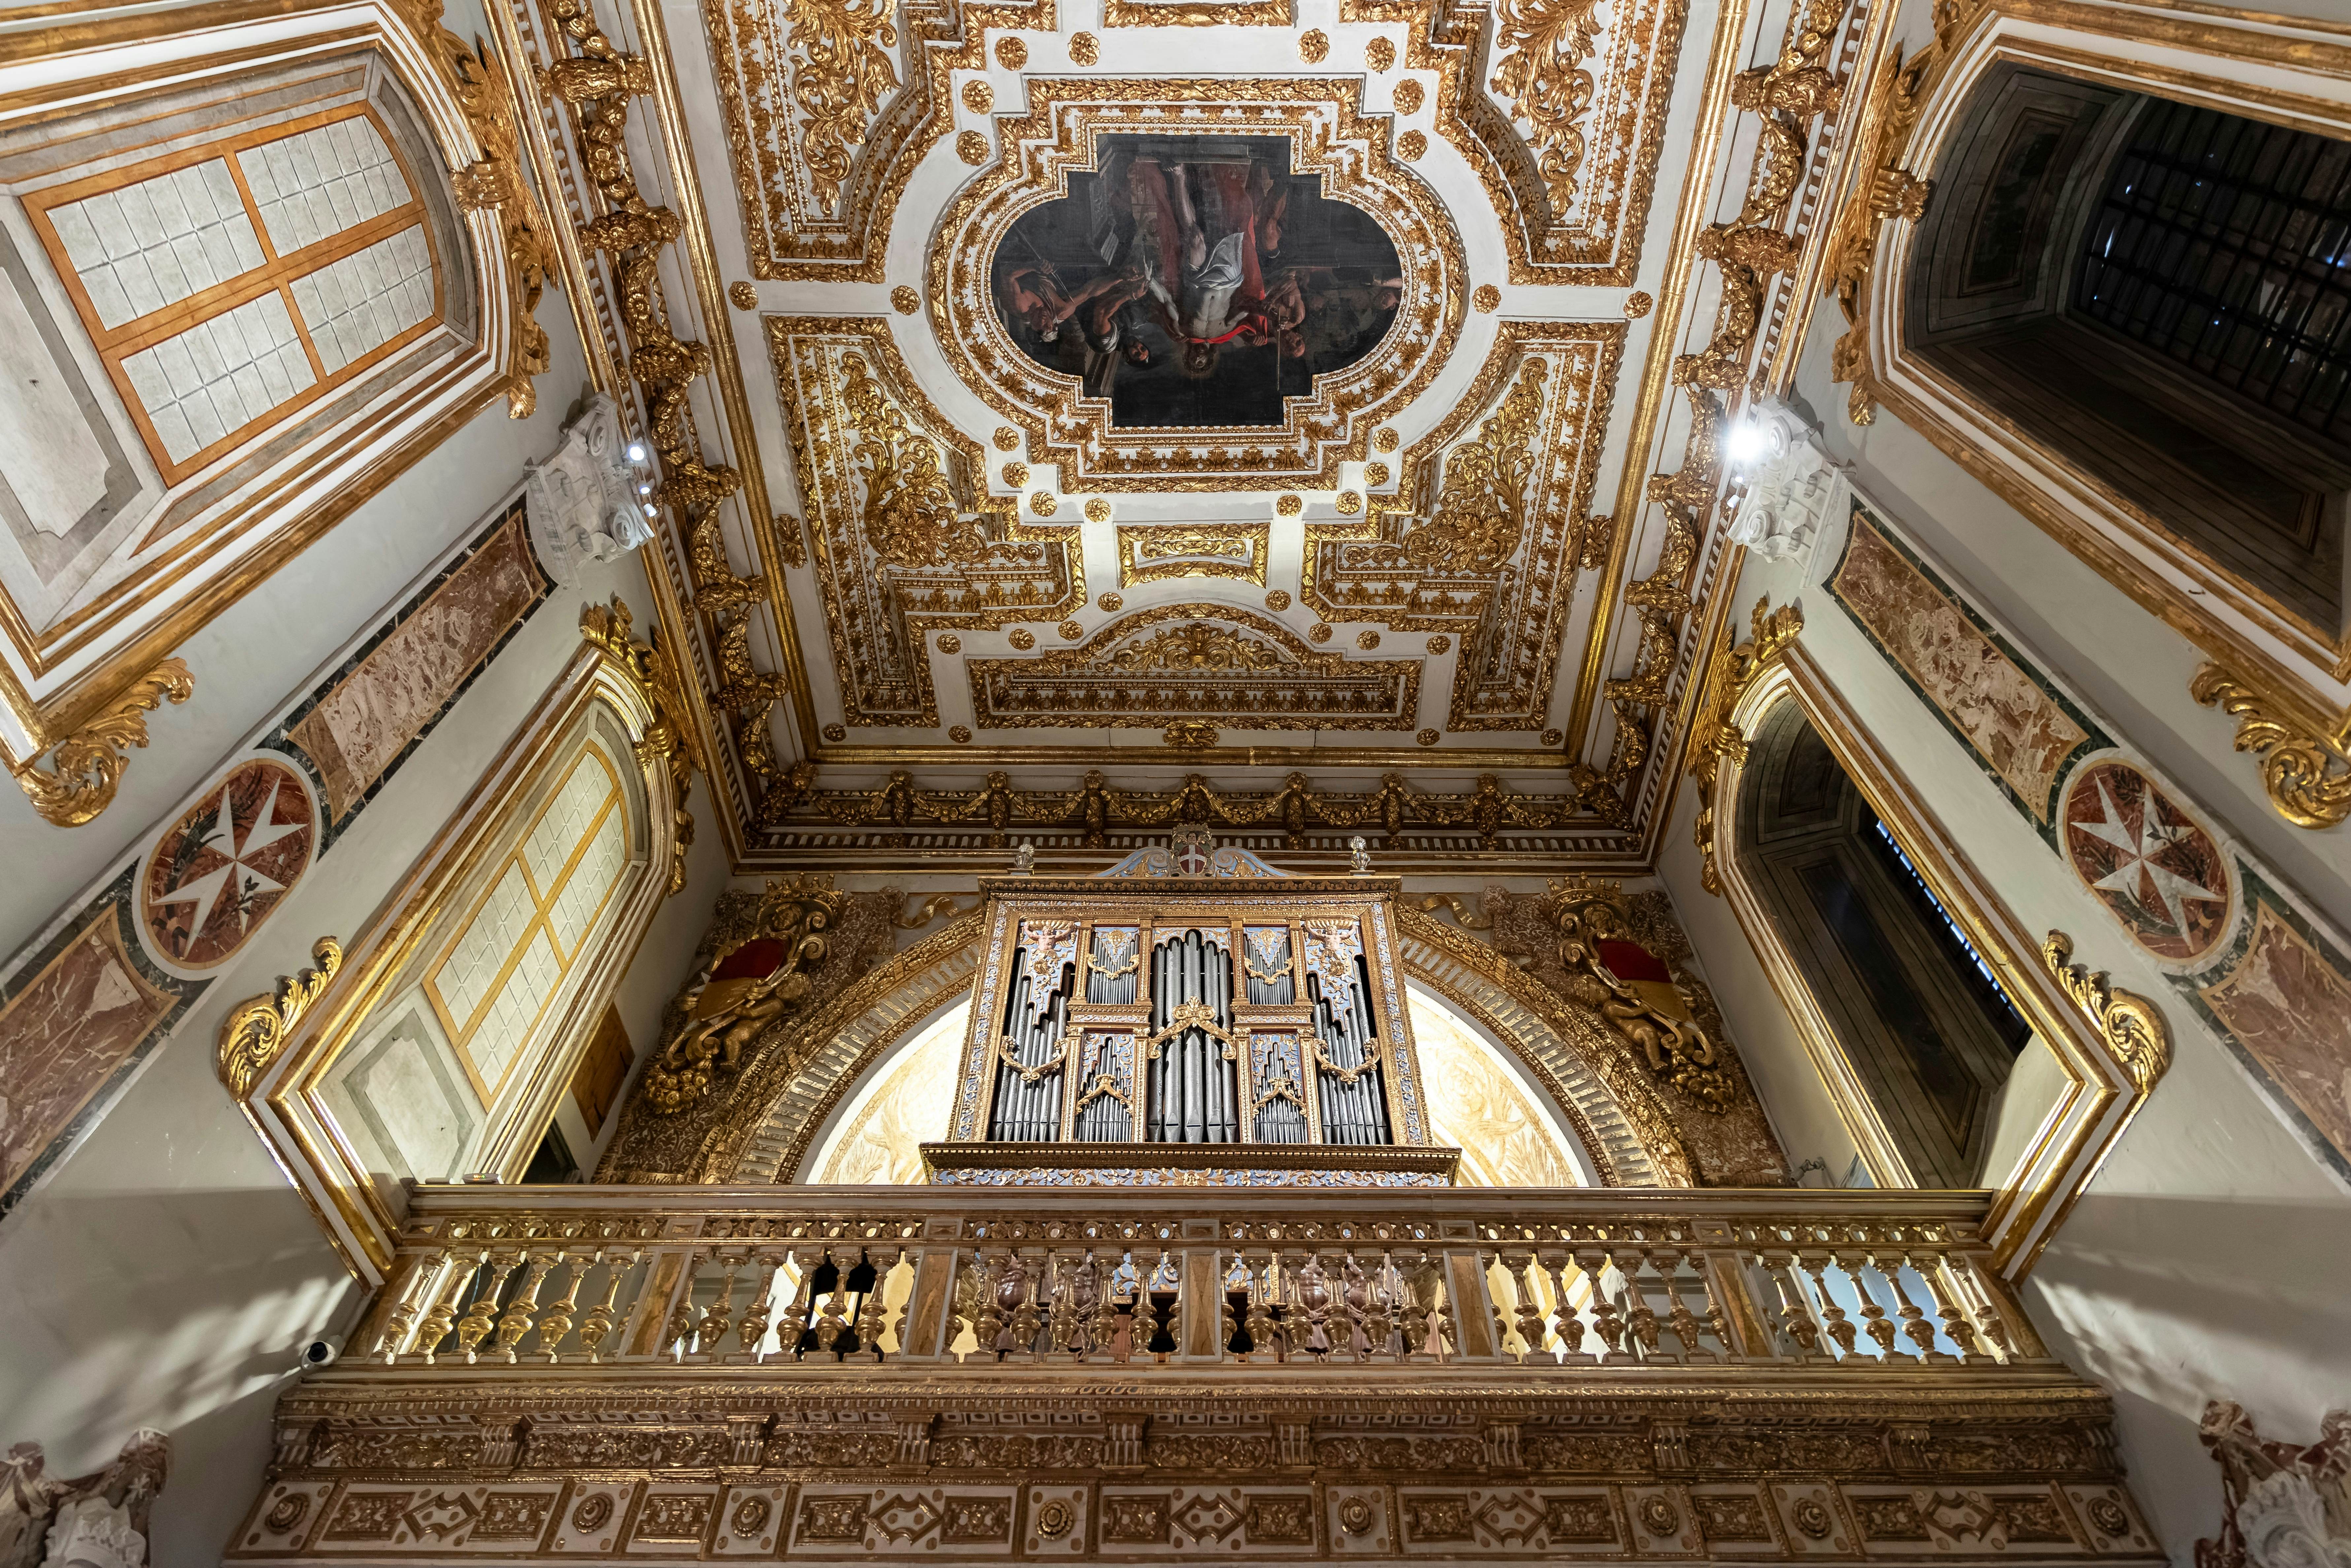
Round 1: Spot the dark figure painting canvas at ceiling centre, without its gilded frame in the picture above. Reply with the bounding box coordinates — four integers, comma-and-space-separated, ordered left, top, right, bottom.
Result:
992, 136, 1403, 428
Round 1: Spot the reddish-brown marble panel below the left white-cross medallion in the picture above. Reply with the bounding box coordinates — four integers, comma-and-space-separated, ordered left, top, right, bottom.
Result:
0, 903, 176, 1192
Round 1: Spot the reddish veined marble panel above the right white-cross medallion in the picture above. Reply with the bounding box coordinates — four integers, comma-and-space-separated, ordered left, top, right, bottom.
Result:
1829, 503, 2102, 832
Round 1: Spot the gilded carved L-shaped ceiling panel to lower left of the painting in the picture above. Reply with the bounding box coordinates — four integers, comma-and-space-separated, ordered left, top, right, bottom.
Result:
764, 315, 1086, 729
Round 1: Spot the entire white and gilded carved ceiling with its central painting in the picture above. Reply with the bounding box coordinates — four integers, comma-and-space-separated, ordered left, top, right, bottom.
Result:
491, 0, 1833, 870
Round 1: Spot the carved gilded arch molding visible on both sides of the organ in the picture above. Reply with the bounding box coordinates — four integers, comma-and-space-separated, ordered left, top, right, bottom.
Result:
687, 910, 1695, 1187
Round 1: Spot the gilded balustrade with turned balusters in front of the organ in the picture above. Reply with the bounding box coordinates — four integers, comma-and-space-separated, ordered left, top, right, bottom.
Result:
353, 1187, 2048, 1380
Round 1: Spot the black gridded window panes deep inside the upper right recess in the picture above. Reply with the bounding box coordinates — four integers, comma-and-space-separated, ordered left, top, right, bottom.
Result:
2073, 101, 2351, 435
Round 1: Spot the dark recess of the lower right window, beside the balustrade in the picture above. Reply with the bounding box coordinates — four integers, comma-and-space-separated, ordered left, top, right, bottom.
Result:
1735, 701, 2031, 1187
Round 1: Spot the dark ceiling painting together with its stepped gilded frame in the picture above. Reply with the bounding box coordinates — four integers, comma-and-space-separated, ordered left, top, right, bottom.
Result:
929, 78, 1469, 491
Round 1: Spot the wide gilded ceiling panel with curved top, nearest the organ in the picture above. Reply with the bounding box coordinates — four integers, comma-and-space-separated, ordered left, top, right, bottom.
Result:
971, 604, 1420, 729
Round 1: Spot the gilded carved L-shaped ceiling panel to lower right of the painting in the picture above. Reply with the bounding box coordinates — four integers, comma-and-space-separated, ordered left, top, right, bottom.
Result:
1300, 322, 1625, 731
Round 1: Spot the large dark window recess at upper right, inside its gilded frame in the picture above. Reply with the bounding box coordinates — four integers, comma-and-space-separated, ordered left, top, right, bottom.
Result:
1904, 63, 2351, 644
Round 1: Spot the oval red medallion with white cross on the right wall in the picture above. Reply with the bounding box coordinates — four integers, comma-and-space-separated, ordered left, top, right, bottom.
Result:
2062, 762, 2229, 964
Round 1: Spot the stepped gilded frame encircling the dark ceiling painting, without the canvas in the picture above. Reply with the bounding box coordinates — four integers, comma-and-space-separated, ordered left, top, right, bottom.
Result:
929, 78, 1469, 491
